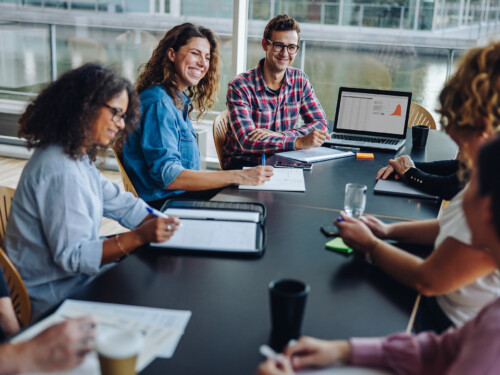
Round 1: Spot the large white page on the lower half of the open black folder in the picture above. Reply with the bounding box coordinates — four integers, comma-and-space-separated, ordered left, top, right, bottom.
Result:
151, 219, 258, 252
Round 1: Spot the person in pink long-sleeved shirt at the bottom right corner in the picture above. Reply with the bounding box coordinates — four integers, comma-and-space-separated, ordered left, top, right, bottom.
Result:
257, 134, 500, 375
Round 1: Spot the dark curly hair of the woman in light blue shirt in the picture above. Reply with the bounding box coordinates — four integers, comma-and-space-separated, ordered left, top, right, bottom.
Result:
18, 63, 140, 161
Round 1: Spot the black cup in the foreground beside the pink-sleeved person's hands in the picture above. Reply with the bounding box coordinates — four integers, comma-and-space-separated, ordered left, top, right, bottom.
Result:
269, 279, 310, 351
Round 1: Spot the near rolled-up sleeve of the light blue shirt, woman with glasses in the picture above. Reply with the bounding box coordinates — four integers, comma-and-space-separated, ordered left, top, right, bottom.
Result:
34, 173, 103, 275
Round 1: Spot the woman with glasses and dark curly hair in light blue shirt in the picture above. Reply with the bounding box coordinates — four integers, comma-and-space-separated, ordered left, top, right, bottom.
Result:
3, 64, 178, 318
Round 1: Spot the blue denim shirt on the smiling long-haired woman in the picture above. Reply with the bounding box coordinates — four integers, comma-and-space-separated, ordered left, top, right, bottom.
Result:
123, 86, 200, 202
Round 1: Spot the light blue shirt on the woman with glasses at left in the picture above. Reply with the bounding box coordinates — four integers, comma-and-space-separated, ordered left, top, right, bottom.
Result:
3, 146, 147, 318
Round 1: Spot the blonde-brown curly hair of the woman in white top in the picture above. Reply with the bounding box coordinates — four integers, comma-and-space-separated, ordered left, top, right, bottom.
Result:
438, 42, 500, 135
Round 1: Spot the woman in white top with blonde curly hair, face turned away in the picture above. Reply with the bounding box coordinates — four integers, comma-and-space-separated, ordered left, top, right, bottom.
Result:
336, 43, 500, 332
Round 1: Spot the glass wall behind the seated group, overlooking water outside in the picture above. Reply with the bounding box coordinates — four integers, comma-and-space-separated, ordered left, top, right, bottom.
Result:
0, 0, 494, 119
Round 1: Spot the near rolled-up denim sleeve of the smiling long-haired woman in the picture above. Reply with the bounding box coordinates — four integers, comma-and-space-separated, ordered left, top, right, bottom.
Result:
141, 100, 184, 188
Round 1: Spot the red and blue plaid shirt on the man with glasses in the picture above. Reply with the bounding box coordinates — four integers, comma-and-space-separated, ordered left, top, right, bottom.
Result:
222, 60, 328, 168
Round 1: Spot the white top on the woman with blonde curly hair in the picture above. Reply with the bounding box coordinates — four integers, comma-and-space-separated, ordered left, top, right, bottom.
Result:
434, 189, 500, 327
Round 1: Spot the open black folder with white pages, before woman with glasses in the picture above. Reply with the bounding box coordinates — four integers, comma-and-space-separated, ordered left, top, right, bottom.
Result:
150, 200, 266, 257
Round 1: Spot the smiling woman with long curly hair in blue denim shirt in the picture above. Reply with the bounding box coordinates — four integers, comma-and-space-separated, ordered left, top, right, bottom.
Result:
123, 23, 273, 208
